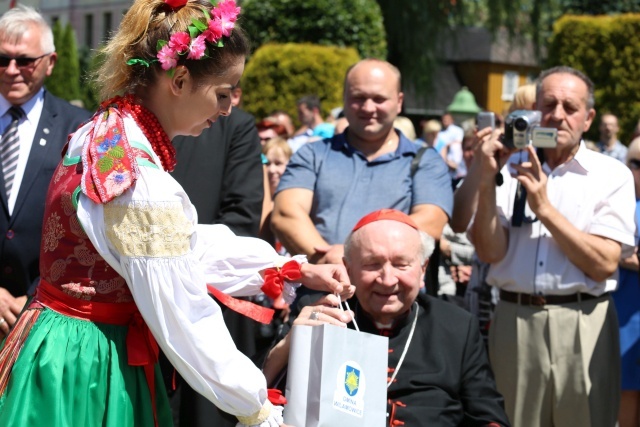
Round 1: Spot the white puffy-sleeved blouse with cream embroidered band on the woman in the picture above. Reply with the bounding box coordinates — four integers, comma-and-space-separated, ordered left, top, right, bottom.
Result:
67, 118, 288, 427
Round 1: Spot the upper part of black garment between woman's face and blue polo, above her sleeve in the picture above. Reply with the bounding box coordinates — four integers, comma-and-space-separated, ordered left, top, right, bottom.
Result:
172, 108, 264, 236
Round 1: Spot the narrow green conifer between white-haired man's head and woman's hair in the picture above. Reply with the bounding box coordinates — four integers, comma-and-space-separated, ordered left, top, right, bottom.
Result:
45, 21, 80, 101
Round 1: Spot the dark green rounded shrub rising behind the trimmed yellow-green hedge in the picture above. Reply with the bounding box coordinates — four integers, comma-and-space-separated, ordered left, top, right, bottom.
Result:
241, 0, 387, 59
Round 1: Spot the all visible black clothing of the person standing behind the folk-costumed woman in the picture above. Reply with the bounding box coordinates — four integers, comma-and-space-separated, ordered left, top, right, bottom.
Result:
168, 108, 264, 427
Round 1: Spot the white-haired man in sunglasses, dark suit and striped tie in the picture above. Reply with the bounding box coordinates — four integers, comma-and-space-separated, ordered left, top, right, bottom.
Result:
0, 5, 90, 338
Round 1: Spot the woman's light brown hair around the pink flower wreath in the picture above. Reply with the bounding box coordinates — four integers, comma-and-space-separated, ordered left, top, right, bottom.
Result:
94, 0, 249, 99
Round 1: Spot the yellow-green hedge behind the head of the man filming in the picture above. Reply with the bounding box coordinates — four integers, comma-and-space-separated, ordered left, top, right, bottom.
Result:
547, 14, 640, 144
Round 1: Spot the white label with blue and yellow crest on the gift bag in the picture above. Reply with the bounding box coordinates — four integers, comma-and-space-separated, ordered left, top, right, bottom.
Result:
333, 360, 366, 418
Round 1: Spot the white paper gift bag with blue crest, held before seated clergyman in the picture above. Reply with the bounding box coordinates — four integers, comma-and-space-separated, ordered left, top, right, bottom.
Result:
284, 324, 389, 427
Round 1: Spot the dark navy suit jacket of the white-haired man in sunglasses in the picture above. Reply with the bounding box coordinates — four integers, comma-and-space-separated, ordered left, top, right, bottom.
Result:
0, 91, 91, 296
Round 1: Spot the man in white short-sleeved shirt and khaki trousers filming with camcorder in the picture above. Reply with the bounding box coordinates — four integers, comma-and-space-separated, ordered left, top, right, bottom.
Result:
470, 67, 635, 427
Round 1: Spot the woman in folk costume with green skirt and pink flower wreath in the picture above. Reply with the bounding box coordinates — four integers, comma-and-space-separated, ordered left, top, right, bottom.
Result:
0, 0, 352, 427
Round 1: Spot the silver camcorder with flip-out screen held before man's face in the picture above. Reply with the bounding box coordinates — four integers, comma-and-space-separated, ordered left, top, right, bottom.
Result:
502, 110, 558, 150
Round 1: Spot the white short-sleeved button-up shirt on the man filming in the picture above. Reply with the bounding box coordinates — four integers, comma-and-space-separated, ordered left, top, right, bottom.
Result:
487, 143, 635, 296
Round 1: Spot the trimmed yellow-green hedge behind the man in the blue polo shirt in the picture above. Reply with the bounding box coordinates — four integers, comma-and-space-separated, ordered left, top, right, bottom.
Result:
242, 43, 359, 121
